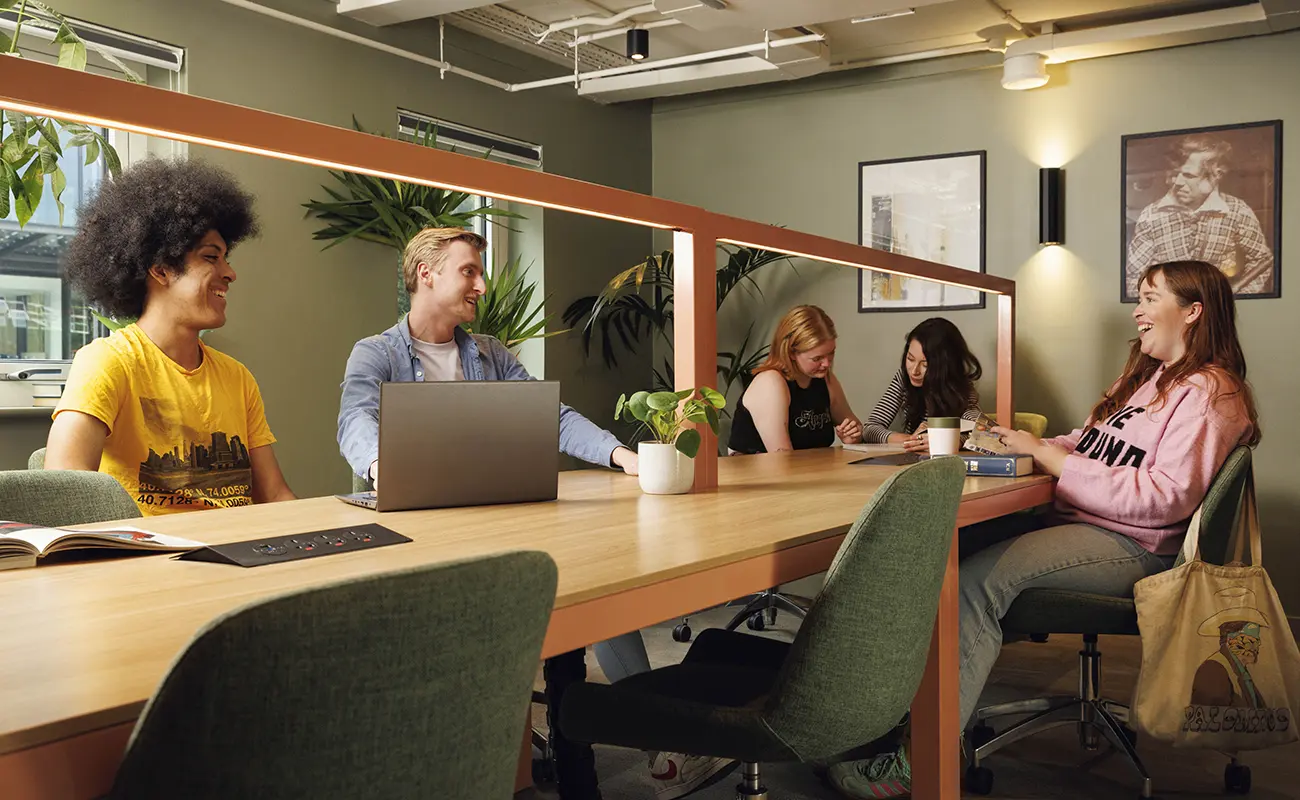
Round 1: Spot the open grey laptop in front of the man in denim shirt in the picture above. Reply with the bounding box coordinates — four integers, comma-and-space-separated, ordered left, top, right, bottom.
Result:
337, 381, 560, 511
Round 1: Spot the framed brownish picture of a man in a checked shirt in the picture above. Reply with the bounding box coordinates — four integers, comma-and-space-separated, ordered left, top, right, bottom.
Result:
1119, 120, 1282, 303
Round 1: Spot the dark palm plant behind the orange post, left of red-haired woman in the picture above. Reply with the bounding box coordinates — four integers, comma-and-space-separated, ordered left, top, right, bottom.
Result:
563, 245, 789, 394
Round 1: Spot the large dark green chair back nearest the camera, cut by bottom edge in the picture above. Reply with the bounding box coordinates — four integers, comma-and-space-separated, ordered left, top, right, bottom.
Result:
109, 553, 556, 800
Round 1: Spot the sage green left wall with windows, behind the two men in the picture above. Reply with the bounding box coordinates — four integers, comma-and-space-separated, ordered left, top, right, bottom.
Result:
24, 0, 650, 496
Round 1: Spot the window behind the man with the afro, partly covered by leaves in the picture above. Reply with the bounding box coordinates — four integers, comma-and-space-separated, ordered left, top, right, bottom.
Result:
0, 10, 185, 372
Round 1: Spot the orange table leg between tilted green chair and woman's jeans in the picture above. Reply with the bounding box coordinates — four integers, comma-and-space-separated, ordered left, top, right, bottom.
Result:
910, 535, 962, 800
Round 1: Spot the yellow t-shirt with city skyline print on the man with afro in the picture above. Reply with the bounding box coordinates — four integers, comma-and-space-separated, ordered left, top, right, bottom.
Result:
55, 325, 276, 516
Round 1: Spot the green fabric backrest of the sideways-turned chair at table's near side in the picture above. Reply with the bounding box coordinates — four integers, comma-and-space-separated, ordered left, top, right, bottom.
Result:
766, 458, 966, 760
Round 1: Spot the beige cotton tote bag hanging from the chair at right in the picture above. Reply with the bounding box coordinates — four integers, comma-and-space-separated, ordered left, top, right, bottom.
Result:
1132, 477, 1300, 753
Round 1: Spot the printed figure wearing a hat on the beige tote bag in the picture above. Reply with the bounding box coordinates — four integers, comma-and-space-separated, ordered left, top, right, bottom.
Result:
1188, 587, 1269, 717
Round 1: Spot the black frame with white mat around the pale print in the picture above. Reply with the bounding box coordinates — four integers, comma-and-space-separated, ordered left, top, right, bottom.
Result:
858, 150, 988, 313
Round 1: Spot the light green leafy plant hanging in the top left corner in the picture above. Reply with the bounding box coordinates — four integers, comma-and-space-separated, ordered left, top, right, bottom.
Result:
0, 0, 135, 228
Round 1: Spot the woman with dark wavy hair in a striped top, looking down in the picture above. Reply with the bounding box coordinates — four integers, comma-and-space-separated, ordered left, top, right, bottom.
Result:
862, 316, 984, 453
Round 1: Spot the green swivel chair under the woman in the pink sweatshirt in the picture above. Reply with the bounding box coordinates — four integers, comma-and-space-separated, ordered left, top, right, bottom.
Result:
966, 446, 1251, 797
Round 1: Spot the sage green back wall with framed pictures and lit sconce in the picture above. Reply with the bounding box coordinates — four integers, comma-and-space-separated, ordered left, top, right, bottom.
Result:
654, 31, 1300, 606
